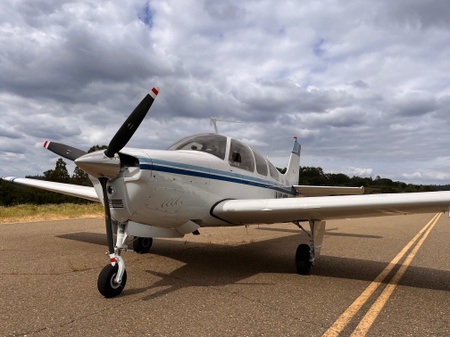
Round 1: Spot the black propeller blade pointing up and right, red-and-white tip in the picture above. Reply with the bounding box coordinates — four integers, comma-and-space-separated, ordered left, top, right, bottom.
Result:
105, 87, 158, 158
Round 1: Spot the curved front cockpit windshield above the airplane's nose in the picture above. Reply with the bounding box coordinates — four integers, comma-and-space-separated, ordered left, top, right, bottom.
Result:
169, 133, 227, 160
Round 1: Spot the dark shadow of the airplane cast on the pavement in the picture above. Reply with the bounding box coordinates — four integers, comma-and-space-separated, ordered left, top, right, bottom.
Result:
58, 232, 450, 300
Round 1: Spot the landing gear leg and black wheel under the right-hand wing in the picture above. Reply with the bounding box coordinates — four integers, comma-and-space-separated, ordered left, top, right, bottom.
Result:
294, 220, 325, 275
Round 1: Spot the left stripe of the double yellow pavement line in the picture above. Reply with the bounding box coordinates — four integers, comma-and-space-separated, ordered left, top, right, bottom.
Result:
322, 213, 441, 337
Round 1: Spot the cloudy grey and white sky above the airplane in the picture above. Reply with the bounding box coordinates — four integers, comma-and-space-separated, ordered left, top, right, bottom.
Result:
0, 0, 450, 184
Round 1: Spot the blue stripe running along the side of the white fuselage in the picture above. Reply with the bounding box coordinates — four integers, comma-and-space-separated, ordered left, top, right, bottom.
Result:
139, 158, 293, 195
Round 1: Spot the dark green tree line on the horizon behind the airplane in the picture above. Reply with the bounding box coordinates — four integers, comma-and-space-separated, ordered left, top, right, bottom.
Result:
0, 155, 444, 206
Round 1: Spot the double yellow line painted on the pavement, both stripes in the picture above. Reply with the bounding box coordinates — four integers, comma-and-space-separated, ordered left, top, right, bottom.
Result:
322, 213, 442, 337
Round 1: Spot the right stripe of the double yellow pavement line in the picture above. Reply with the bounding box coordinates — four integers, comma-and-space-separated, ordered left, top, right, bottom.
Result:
351, 213, 442, 337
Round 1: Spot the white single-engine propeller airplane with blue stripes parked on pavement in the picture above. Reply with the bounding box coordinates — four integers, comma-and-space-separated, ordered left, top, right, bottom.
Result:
2, 87, 450, 298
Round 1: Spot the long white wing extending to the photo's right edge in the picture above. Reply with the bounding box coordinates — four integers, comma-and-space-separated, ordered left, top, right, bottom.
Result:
211, 192, 450, 224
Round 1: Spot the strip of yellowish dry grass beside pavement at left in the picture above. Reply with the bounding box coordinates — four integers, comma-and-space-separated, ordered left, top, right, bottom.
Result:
0, 204, 103, 223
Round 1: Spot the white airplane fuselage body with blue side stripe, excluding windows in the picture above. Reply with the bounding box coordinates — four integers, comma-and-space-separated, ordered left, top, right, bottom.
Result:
92, 133, 294, 229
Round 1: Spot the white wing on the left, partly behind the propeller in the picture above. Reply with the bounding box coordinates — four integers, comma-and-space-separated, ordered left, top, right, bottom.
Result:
2, 177, 100, 202
